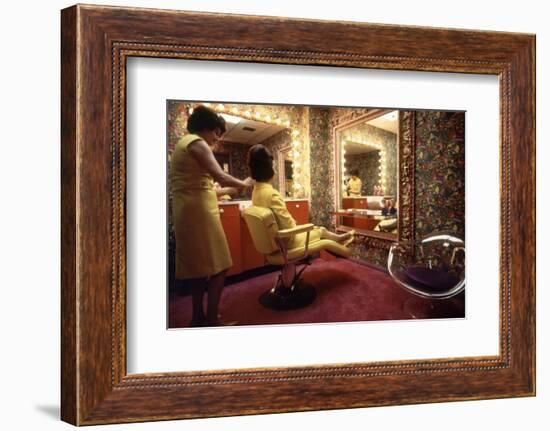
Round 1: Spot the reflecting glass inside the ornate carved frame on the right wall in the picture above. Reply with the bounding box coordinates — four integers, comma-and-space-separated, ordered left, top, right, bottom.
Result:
337, 111, 399, 238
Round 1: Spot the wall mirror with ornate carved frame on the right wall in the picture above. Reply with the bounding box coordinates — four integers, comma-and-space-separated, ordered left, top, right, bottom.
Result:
334, 109, 414, 247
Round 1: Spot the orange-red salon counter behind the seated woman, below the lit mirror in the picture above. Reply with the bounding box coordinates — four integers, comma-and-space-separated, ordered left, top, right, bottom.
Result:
218, 199, 309, 275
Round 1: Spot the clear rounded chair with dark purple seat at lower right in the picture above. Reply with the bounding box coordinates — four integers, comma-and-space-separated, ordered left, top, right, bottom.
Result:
388, 232, 466, 318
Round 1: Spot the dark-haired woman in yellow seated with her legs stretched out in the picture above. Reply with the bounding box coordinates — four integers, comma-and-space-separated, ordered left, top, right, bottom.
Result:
248, 144, 354, 249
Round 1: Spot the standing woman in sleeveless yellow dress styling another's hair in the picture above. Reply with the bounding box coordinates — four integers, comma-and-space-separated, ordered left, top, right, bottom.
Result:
170, 106, 253, 326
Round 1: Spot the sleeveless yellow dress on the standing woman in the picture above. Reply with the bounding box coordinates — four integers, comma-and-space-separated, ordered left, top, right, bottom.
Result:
170, 135, 233, 279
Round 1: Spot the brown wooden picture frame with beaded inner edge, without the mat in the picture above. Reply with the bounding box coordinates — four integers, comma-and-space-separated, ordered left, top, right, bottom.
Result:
61, 5, 535, 425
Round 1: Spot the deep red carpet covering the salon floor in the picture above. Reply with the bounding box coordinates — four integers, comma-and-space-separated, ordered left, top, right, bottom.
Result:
169, 259, 464, 328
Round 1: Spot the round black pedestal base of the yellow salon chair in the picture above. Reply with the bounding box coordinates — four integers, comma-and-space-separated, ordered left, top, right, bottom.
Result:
259, 277, 317, 310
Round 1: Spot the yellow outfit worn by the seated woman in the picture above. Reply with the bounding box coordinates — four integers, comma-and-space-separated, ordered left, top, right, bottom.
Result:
252, 182, 321, 249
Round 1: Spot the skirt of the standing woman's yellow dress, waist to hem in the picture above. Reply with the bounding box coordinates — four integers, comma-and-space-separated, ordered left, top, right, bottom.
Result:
172, 189, 233, 279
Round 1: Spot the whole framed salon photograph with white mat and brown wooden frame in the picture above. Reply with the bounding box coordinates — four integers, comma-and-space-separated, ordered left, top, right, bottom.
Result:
61, 5, 535, 425
